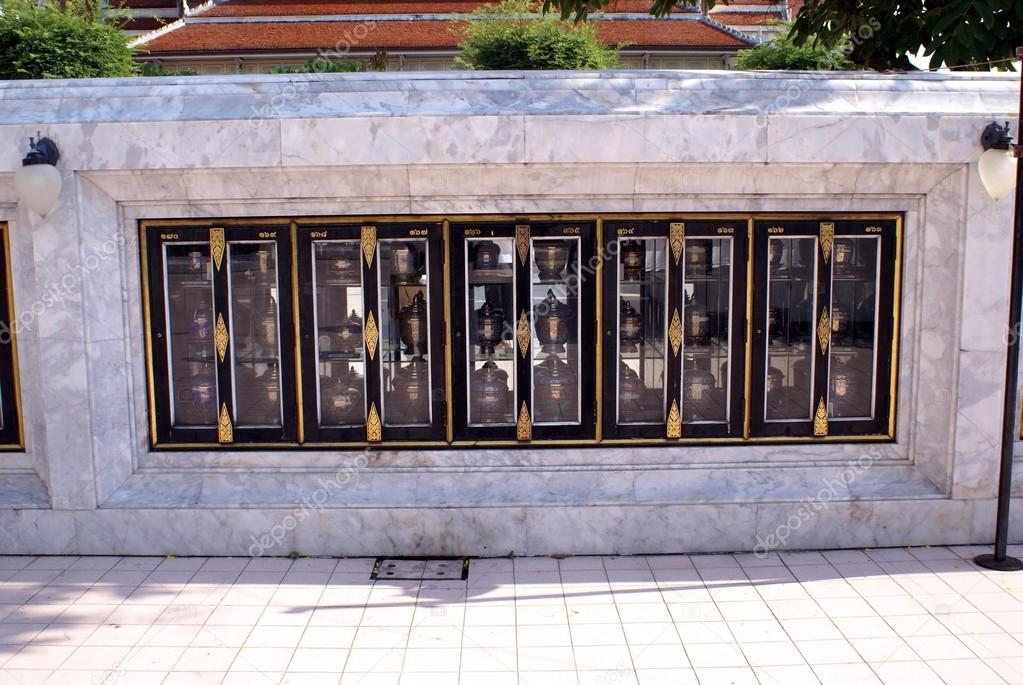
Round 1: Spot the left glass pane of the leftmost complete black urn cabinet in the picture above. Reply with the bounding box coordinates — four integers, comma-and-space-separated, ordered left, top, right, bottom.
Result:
163, 242, 218, 427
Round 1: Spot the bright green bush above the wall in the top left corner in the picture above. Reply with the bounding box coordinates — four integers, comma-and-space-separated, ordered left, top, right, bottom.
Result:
0, 0, 137, 79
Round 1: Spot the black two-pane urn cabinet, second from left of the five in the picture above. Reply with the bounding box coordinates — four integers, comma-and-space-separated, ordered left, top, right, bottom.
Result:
298, 223, 445, 443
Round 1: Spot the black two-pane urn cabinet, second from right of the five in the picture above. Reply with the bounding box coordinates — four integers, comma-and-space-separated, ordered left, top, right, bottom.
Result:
603, 220, 747, 440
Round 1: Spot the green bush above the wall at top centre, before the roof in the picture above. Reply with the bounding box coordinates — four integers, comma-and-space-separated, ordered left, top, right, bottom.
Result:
456, 0, 618, 70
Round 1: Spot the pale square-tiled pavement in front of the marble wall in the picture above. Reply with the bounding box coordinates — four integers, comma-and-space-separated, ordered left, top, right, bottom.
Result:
0, 547, 1023, 685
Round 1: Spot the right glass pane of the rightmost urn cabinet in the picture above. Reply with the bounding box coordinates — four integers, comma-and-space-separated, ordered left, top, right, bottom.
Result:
828, 236, 881, 419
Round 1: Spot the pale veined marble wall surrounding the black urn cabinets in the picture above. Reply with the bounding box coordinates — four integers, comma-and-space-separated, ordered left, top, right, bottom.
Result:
0, 72, 1023, 555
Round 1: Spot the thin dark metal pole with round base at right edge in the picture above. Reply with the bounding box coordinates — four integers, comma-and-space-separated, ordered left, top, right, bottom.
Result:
974, 48, 1023, 570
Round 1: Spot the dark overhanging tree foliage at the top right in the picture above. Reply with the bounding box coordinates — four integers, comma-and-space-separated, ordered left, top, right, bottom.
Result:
543, 0, 1023, 70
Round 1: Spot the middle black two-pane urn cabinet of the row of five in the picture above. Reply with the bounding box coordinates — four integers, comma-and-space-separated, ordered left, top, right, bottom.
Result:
450, 222, 596, 442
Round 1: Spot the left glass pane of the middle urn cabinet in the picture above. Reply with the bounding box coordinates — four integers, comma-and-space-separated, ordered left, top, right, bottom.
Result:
464, 238, 516, 426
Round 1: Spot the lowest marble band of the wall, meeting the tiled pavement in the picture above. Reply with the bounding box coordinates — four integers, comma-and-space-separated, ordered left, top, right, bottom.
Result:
0, 499, 1006, 556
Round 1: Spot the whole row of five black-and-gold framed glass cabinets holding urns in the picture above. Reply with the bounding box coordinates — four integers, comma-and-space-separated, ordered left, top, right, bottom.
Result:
142, 215, 901, 449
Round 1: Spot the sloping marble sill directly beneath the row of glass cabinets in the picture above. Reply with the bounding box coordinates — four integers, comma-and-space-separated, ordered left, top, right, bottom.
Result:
101, 465, 944, 510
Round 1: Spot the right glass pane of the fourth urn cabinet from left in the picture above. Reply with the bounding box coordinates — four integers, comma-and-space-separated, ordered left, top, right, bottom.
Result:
682, 237, 733, 423
